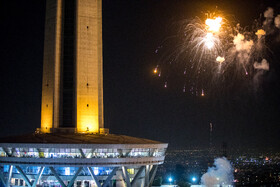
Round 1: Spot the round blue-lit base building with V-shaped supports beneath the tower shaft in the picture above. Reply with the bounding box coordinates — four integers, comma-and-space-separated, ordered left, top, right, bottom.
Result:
0, 133, 167, 187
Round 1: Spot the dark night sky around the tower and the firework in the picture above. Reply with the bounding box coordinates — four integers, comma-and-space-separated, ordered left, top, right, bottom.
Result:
0, 0, 280, 148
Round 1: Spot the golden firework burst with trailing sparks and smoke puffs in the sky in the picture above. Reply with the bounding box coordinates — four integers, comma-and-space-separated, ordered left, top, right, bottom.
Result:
154, 7, 280, 96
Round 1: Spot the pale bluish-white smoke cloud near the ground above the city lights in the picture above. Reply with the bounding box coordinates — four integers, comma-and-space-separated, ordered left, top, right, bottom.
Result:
201, 157, 234, 187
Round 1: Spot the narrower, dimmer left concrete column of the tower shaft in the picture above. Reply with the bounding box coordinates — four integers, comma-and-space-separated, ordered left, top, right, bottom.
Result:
41, 0, 62, 133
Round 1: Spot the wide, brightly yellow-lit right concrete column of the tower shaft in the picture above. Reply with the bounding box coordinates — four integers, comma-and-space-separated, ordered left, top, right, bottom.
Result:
76, 0, 103, 132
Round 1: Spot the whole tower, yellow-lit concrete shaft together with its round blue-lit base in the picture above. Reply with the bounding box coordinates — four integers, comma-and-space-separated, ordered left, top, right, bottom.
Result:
0, 0, 168, 187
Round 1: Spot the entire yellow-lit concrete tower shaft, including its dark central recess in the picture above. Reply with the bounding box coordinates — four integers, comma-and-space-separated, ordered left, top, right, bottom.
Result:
41, 0, 104, 133
